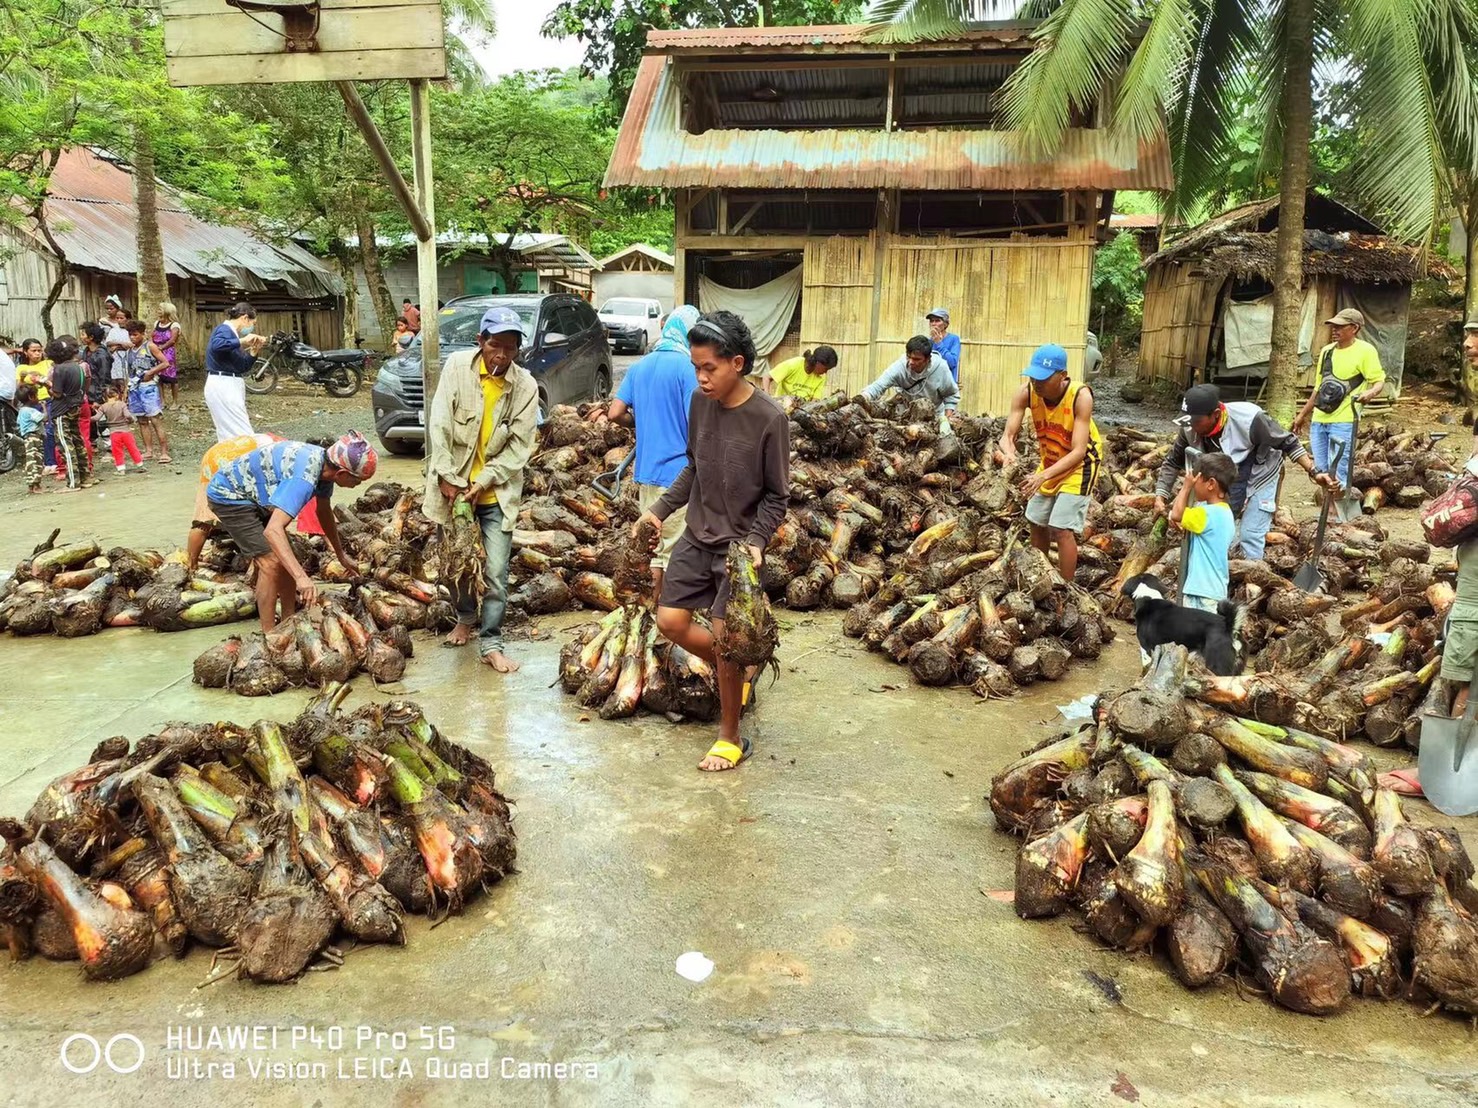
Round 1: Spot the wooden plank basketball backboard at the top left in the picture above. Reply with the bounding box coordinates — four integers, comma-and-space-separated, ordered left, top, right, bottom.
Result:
163, 0, 446, 86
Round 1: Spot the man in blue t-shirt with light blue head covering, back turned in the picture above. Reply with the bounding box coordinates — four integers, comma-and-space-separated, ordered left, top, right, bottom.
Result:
591, 304, 698, 595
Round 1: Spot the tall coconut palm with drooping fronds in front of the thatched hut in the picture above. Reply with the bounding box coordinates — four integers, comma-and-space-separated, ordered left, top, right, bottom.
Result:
869, 0, 1478, 420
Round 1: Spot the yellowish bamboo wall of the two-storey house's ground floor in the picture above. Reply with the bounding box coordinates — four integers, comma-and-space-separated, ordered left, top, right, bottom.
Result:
801, 235, 1094, 414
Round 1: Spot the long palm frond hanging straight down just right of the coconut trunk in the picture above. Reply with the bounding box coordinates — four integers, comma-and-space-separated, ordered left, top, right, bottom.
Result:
1345, 0, 1450, 241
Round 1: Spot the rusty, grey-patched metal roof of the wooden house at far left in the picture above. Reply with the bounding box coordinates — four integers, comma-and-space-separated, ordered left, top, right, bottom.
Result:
46, 148, 343, 300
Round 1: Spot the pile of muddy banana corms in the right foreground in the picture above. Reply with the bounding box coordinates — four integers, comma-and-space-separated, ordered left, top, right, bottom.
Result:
989, 647, 1478, 1015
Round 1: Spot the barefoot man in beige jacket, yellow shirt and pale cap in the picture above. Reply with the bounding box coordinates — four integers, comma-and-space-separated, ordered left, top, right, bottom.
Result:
423, 299, 539, 674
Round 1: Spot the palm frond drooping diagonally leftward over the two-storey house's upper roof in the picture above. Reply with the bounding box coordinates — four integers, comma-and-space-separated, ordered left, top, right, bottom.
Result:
1002, 0, 1140, 157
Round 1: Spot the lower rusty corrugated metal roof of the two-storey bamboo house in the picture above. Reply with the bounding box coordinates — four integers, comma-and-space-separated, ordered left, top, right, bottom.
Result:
606, 56, 1174, 191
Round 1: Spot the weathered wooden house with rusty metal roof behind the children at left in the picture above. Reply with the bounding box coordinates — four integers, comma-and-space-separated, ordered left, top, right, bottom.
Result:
0, 148, 343, 365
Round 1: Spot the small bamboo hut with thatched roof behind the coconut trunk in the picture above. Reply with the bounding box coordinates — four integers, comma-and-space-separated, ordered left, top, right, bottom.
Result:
1140, 192, 1441, 396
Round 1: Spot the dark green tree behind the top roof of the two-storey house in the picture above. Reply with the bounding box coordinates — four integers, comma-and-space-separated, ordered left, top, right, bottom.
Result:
544, 0, 862, 124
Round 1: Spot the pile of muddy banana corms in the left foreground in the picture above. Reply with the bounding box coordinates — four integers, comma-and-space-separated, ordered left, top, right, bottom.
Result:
0, 685, 514, 981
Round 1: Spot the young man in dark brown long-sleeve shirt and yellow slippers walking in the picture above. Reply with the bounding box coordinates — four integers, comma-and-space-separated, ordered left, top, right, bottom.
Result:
637, 312, 791, 770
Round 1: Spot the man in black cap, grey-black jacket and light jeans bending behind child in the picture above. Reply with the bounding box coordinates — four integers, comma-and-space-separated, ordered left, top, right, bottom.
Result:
1154, 384, 1339, 561
